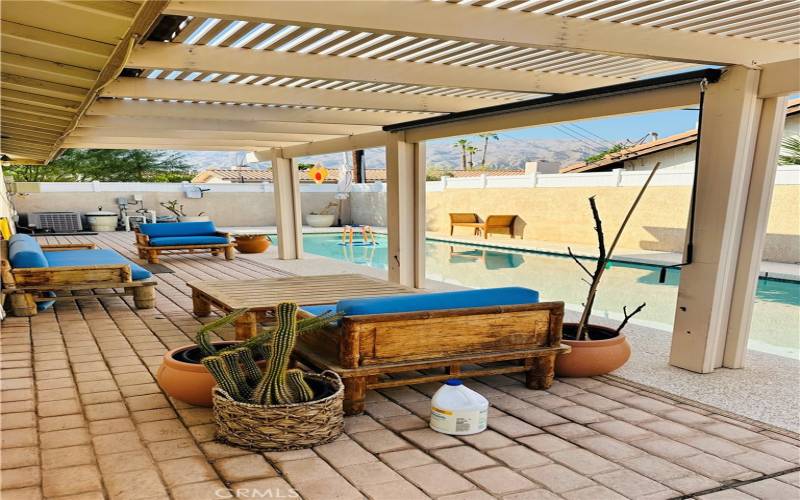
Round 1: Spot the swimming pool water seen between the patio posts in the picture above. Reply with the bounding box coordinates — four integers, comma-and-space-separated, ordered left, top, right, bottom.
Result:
296, 233, 800, 358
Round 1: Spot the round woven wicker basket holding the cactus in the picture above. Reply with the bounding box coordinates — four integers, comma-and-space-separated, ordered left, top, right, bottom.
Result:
209, 371, 344, 451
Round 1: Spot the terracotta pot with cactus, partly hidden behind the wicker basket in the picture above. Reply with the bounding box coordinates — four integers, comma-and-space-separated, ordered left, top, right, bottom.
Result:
156, 309, 338, 406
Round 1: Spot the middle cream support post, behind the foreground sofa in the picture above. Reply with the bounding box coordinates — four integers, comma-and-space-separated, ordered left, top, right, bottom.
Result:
386, 134, 425, 288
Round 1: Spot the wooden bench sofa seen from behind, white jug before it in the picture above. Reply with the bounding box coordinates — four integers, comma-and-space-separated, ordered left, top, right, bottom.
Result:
295, 287, 569, 414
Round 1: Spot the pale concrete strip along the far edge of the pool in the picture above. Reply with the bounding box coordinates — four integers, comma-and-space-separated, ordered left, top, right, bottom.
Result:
220, 226, 800, 282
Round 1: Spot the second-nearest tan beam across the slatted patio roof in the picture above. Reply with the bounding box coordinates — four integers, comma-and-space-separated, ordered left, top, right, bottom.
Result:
127, 42, 628, 94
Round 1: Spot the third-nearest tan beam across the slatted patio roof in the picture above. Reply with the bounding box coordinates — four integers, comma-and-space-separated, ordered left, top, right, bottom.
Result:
102, 78, 508, 113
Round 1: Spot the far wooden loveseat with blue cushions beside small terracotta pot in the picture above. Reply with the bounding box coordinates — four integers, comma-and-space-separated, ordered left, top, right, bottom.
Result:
135, 221, 234, 264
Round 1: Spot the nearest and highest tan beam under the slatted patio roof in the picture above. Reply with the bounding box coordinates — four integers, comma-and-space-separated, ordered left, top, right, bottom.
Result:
166, 0, 797, 65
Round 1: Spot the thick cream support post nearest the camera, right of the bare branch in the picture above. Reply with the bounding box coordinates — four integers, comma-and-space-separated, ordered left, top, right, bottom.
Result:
670, 67, 759, 373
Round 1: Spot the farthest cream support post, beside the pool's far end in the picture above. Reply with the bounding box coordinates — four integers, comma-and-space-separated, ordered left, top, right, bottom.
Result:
272, 149, 303, 260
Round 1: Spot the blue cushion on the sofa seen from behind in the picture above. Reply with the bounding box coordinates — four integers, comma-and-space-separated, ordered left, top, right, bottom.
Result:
336, 287, 539, 316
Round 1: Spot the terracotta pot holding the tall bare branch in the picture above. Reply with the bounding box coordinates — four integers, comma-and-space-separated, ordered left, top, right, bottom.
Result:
556, 323, 631, 377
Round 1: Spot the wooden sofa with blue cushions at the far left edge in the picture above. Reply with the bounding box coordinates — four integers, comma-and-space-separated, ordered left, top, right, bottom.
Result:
0, 234, 156, 316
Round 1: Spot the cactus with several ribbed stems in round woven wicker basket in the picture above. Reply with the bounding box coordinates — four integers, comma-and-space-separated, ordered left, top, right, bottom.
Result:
203, 302, 344, 451
